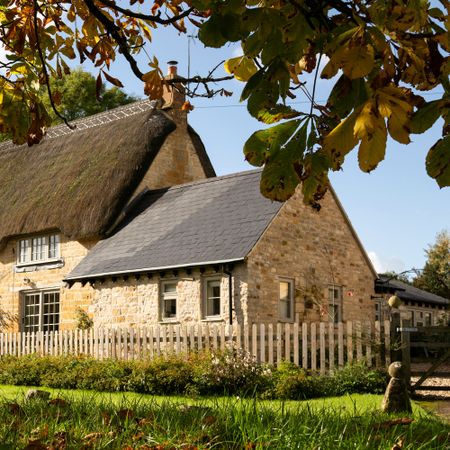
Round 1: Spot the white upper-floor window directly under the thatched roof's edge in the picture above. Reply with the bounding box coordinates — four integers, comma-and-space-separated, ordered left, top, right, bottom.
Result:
17, 234, 60, 264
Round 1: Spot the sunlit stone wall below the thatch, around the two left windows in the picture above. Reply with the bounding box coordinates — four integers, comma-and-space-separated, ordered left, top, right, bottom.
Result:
0, 235, 97, 331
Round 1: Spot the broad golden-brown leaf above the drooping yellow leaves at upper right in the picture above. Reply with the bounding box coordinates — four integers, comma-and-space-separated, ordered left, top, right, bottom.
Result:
330, 39, 375, 79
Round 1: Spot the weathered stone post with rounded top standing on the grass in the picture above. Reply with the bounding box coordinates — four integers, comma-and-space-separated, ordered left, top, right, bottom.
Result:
381, 361, 412, 413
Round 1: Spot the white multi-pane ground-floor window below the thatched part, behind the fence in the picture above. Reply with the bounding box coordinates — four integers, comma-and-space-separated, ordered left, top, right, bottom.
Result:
22, 291, 59, 332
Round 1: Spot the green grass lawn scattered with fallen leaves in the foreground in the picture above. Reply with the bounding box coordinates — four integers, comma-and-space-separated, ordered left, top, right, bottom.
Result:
0, 386, 450, 450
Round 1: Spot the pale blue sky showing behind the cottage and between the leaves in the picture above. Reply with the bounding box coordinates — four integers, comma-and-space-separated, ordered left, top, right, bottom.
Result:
85, 28, 450, 272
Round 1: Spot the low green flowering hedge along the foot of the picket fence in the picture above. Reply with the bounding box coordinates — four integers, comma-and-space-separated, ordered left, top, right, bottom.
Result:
0, 351, 388, 399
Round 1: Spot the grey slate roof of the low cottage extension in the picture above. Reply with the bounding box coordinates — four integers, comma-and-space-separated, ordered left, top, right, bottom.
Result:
66, 170, 282, 280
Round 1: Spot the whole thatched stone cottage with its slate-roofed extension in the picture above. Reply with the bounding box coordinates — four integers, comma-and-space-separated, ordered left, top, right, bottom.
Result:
0, 89, 376, 331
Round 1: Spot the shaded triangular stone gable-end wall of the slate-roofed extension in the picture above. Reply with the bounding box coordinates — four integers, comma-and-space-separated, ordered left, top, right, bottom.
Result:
247, 187, 375, 323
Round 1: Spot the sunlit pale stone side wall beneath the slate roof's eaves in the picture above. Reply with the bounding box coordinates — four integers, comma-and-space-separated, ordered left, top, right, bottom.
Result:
88, 265, 247, 328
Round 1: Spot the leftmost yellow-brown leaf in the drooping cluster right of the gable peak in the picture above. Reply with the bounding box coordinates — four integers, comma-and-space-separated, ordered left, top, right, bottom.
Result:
322, 111, 359, 169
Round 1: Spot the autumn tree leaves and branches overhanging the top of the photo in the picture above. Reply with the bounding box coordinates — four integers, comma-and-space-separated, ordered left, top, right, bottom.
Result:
0, 0, 450, 206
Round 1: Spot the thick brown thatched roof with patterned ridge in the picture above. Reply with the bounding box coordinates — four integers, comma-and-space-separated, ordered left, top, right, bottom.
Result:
0, 101, 209, 248
